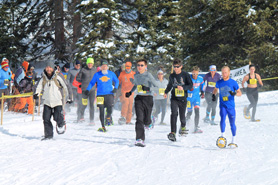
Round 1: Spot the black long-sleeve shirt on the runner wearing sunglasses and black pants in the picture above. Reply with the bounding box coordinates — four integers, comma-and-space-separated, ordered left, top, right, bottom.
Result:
165, 71, 193, 100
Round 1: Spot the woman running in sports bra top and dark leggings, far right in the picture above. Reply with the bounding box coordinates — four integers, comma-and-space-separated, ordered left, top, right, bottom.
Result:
242, 64, 264, 122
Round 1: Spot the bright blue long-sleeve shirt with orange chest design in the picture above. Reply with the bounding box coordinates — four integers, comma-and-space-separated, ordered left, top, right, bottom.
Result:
87, 70, 119, 96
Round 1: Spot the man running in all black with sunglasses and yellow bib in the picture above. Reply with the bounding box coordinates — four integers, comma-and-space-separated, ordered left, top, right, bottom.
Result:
164, 59, 193, 141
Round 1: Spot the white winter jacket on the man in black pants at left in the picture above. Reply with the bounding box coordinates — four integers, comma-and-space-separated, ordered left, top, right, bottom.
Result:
34, 71, 73, 108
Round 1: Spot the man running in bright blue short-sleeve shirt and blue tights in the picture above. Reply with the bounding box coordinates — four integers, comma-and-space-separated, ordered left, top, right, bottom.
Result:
212, 66, 241, 148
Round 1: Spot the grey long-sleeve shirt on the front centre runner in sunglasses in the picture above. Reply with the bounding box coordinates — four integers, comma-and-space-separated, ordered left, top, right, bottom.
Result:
131, 71, 159, 96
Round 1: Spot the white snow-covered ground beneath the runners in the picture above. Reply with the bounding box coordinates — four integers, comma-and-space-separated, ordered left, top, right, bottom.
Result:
0, 91, 278, 185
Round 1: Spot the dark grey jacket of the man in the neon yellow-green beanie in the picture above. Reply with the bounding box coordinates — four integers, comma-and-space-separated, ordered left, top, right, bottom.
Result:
76, 66, 97, 91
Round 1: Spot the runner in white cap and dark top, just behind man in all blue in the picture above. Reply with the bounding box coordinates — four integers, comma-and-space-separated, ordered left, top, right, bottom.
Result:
204, 65, 221, 125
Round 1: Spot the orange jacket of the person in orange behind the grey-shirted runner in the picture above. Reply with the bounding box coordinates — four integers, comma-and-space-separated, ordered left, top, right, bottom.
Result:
119, 71, 135, 93
